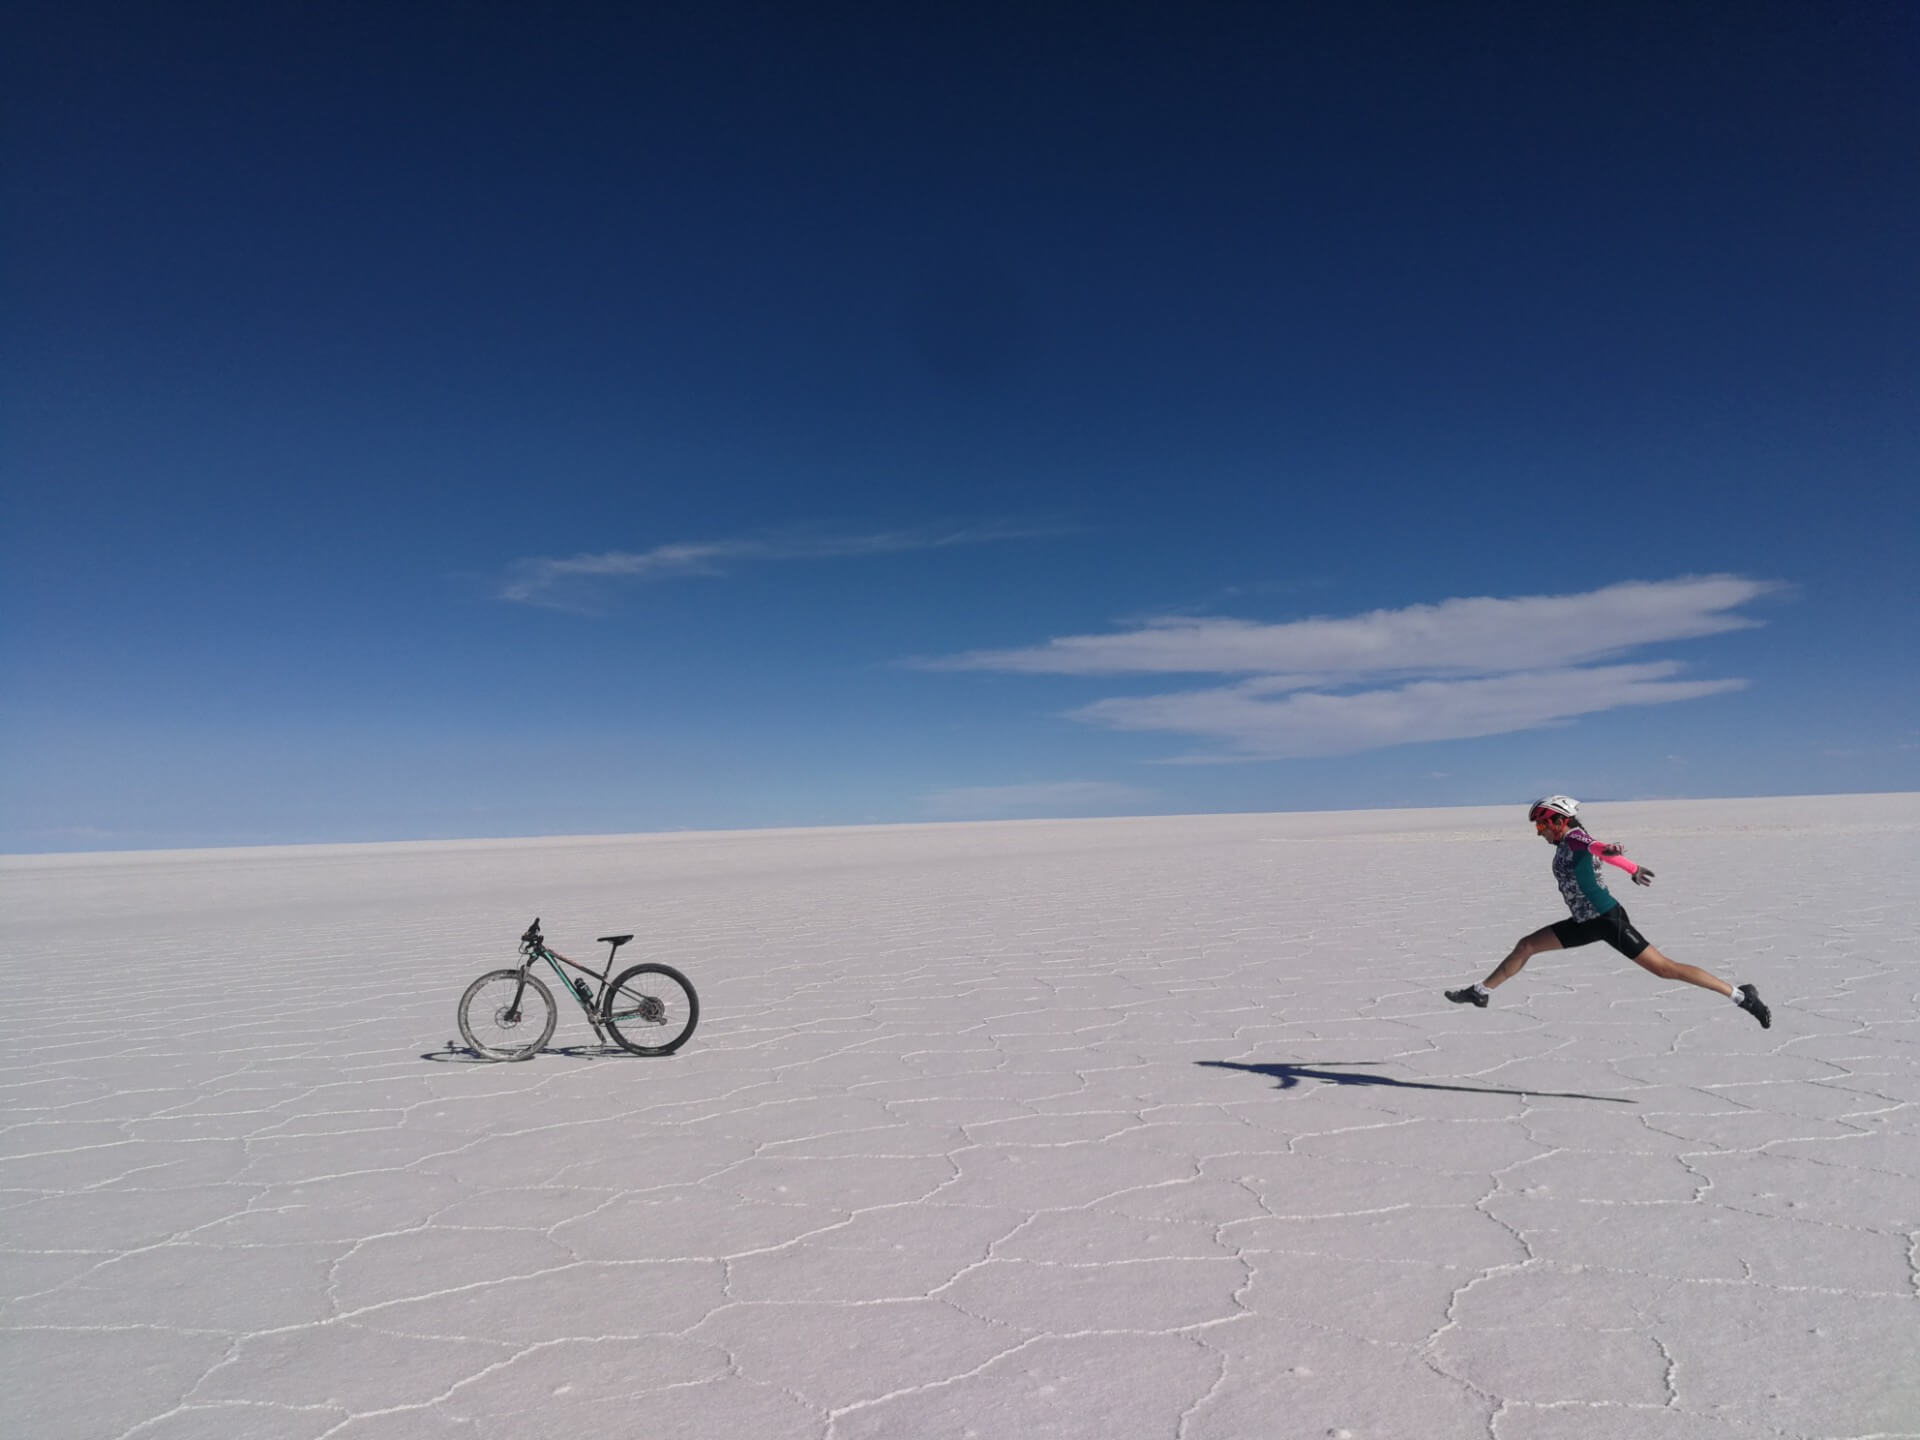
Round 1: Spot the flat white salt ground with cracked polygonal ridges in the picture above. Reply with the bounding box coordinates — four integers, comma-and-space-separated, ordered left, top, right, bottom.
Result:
0, 795, 1920, 1440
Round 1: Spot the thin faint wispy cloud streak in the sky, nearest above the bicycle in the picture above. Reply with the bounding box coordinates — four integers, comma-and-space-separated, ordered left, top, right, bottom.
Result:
499, 526, 1064, 611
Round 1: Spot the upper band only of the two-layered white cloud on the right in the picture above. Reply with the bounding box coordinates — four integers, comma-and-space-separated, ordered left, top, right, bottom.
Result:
924, 574, 1778, 689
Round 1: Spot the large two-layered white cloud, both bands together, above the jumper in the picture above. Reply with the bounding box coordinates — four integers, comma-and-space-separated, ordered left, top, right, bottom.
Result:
920, 576, 1778, 764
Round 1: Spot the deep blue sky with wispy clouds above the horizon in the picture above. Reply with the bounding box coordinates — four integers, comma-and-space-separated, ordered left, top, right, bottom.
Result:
0, 0, 1920, 852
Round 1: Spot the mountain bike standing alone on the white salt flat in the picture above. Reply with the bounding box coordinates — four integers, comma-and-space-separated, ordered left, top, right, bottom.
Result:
461, 918, 701, 1060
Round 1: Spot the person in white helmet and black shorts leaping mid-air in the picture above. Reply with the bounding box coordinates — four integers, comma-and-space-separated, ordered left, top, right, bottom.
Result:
1446, 795, 1774, 1029
